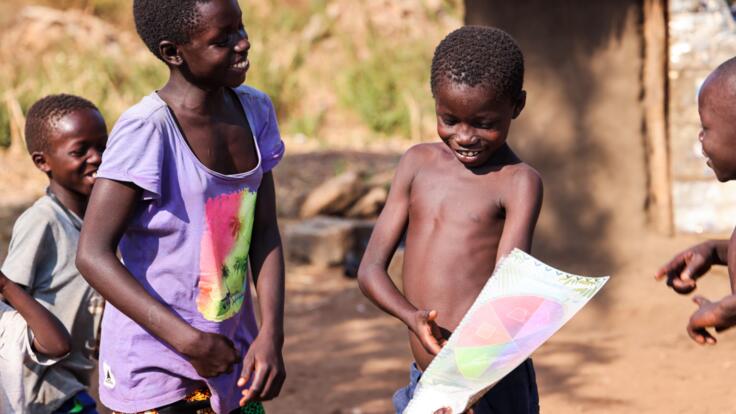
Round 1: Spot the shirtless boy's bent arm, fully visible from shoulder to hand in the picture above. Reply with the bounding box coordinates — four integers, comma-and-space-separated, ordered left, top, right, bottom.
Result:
358, 147, 444, 355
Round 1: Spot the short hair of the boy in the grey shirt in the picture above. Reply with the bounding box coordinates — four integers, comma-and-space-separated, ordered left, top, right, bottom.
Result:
25, 94, 99, 154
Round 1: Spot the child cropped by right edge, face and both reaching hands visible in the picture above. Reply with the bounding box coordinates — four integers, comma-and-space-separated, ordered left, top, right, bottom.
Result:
655, 58, 736, 345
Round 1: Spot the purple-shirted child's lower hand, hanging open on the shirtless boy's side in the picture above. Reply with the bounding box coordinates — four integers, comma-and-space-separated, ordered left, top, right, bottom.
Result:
238, 334, 286, 407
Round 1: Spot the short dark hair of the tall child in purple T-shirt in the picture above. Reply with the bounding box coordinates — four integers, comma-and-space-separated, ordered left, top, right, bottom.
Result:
133, 0, 209, 60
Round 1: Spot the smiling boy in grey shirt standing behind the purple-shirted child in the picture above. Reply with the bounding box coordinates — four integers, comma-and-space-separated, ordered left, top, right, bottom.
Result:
2, 94, 107, 414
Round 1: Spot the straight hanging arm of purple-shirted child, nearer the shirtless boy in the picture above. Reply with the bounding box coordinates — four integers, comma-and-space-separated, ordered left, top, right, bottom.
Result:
238, 172, 286, 405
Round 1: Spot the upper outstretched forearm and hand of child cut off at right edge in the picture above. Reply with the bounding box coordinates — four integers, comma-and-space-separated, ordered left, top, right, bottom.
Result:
654, 236, 734, 294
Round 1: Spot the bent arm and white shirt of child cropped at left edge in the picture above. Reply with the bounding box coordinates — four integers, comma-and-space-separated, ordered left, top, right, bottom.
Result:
0, 273, 71, 413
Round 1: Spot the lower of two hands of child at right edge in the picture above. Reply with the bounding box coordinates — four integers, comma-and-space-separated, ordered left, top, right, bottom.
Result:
687, 296, 736, 345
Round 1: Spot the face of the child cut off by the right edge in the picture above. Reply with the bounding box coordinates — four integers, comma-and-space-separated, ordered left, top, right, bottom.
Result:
698, 74, 736, 182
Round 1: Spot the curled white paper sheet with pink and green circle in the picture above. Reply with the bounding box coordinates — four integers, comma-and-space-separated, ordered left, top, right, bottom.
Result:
403, 249, 608, 414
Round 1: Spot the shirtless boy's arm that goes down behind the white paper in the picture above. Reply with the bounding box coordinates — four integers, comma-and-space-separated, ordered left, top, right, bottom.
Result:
496, 167, 544, 264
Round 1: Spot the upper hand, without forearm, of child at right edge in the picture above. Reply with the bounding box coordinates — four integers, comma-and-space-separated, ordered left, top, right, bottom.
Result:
654, 242, 714, 294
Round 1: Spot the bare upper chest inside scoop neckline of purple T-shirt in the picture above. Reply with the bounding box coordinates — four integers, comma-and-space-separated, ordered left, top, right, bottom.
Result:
180, 115, 258, 174
